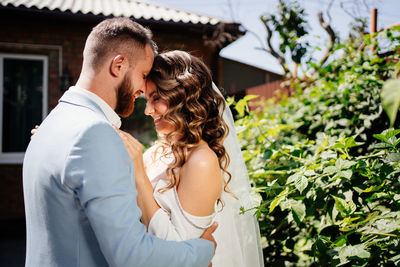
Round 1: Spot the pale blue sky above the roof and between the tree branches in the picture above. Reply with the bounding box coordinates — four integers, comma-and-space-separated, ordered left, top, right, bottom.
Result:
147, 0, 400, 73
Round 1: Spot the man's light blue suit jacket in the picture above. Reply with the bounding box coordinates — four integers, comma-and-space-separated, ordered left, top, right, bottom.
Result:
23, 90, 214, 267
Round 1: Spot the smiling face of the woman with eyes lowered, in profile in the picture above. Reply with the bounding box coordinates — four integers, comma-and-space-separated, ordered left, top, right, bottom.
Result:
144, 80, 174, 135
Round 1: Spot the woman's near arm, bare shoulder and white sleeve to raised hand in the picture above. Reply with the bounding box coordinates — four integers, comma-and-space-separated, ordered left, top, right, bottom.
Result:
118, 130, 222, 241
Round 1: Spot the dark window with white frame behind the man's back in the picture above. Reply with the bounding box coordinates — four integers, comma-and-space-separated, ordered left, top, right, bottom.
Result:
0, 54, 48, 163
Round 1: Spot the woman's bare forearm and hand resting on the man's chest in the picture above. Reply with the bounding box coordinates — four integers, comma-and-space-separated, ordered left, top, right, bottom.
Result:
117, 129, 160, 227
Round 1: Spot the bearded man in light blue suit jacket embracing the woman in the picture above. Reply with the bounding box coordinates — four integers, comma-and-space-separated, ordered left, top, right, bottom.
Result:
23, 18, 216, 267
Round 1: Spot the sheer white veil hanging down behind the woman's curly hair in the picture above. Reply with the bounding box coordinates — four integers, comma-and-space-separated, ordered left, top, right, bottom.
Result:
213, 83, 264, 267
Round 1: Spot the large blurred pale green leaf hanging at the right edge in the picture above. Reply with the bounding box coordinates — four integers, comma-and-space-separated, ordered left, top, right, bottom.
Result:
381, 80, 400, 127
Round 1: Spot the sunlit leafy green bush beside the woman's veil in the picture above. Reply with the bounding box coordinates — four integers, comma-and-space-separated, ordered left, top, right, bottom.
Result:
232, 28, 400, 266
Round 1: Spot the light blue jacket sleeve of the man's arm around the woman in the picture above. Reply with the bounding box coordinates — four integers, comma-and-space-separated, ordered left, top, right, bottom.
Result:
63, 122, 214, 267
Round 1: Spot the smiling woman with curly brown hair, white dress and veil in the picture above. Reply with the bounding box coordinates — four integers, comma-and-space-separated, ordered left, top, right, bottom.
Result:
119, 51, 263, 267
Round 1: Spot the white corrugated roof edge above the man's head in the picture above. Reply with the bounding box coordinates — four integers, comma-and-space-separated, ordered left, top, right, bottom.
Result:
0, 0, 236, 25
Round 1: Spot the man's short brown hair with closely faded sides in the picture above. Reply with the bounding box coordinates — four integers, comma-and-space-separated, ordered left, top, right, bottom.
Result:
83, 18, 157, 70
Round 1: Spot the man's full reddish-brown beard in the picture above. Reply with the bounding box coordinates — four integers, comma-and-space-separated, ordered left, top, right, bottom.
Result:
115, 75, 135, 118
